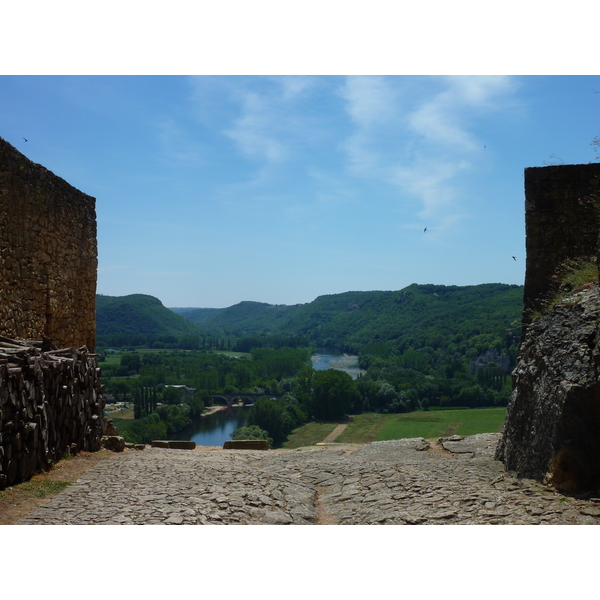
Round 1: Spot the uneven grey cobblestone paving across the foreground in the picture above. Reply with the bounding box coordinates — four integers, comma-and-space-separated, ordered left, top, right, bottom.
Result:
19, 434, 600, 525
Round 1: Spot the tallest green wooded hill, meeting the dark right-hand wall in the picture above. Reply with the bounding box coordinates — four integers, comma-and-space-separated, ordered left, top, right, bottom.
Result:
290, 284, 523, 351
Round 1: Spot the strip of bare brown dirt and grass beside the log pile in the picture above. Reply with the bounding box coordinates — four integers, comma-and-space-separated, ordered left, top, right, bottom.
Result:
0, 450, 113, 525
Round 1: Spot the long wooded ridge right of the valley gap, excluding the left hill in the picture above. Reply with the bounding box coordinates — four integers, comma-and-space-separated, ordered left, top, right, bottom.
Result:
186, 283, 523, 352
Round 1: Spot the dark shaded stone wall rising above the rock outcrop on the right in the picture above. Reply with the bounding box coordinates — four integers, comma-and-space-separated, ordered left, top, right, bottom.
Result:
521, 164, 600, 332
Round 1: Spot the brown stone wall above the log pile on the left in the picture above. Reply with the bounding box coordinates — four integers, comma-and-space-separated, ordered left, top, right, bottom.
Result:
0, 138, 97, 351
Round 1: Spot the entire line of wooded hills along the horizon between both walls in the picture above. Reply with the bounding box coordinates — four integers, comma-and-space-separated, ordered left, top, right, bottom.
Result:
96, 283, 523, 357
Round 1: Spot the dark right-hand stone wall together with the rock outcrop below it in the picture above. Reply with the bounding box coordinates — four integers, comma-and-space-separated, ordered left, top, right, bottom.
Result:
496, 164, 600, 493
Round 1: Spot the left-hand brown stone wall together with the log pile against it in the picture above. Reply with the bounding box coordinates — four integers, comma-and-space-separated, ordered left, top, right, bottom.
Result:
0, 138, 104, 489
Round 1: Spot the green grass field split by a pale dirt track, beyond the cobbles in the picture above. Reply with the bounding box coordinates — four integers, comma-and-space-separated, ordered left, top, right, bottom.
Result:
283, 408, 506, 449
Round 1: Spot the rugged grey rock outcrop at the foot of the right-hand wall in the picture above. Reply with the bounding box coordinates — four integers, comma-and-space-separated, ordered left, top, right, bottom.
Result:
496, 283, 600, 492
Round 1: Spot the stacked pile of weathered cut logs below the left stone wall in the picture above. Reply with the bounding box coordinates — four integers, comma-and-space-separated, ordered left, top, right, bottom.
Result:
0, 336, 104, 490
